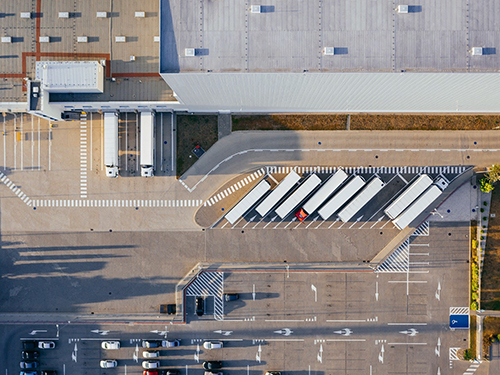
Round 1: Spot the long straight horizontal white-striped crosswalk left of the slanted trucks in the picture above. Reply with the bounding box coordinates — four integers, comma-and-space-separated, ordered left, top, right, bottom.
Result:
30, 199, 203, 208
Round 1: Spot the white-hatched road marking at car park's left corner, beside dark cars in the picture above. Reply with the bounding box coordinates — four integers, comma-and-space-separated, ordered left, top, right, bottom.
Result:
184, 271, 224, 321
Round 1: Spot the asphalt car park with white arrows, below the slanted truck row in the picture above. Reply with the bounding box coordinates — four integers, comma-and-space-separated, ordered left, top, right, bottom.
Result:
0, 222, 469, 374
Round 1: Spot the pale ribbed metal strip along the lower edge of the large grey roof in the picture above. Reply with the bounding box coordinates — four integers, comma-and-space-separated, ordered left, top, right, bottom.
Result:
162, 73, 500, 113
